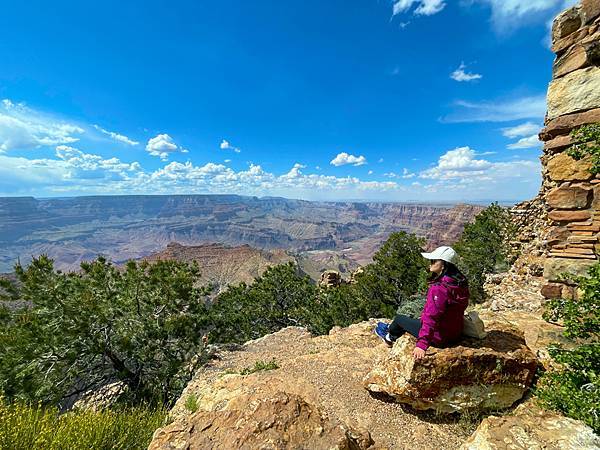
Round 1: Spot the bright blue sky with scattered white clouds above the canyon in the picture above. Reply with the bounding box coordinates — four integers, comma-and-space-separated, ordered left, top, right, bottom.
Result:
0, 0, 576, 201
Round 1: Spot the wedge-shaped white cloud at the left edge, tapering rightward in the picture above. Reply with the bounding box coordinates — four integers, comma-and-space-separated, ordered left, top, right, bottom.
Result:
0, 99, 84, 152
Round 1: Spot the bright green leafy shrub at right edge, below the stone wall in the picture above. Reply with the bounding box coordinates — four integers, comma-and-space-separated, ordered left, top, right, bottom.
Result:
537, 264, 600, 433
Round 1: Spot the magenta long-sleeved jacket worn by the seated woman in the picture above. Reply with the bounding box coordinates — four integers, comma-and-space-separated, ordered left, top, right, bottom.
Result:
417, 276, 469, 350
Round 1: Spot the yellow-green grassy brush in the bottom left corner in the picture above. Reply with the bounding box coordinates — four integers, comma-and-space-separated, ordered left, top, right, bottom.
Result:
0, 399, 166, 450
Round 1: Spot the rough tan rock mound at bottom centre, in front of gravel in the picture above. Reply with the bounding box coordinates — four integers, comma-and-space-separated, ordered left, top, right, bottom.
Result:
149, 392, 373, 450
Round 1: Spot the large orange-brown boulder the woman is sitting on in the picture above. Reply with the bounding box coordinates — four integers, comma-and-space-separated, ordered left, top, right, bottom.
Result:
364, 324, 537, 413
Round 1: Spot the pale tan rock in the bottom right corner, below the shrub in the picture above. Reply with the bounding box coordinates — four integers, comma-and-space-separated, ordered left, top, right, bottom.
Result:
461, 402, 600, 450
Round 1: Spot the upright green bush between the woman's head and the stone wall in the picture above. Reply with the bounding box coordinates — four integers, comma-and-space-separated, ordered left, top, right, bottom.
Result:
454, 203, 515, 302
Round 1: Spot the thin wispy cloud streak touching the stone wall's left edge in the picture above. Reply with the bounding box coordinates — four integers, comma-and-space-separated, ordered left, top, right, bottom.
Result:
440, 95, 546, 123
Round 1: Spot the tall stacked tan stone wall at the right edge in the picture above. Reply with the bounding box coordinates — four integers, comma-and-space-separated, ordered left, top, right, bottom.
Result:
540, 0, 600, 298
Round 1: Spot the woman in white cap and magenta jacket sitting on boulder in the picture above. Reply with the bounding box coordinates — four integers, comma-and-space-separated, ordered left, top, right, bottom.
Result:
375, 246, 469, 359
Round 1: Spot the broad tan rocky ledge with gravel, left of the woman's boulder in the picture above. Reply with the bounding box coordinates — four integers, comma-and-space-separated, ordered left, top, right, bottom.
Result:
151, 320, 482, 450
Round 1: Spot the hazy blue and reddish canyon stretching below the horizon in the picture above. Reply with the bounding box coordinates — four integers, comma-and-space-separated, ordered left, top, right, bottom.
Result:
0, 195, 483, 272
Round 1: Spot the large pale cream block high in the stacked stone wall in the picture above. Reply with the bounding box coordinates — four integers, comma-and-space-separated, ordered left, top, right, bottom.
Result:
547, 67, 600, 120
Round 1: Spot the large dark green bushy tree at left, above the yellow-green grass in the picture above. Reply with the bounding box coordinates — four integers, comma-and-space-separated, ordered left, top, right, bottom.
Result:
0, 256, 213, 403
